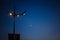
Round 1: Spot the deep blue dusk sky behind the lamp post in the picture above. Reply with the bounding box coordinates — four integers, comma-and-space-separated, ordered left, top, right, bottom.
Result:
0, 0, 60, 40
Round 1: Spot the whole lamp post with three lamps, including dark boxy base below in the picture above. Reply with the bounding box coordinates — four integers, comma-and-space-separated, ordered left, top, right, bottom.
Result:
8, 0, 26, 40
